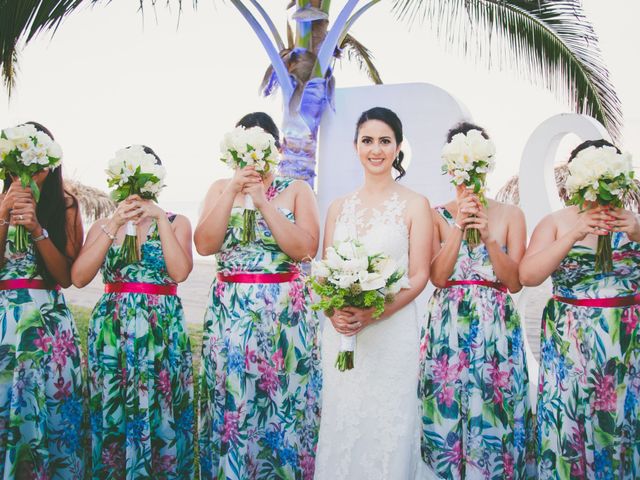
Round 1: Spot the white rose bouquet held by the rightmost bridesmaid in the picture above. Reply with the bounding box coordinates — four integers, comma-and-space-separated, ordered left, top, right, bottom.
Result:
566, 146, 636, 272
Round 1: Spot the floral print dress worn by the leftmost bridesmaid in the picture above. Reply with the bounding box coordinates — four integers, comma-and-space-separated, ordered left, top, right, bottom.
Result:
0, 227, 88, 480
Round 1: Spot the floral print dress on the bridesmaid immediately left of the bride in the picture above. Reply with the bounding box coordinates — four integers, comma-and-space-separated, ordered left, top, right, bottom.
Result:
199, 177, 321, 480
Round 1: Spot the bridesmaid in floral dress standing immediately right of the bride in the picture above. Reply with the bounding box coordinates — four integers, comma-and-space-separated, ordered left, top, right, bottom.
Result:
419, 123, 532, 479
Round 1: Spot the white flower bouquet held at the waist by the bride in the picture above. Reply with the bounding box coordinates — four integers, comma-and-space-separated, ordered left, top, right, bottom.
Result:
311, 240, 409, 372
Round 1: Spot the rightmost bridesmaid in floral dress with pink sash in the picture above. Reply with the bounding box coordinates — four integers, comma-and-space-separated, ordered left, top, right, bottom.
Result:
520, 140, 640, 480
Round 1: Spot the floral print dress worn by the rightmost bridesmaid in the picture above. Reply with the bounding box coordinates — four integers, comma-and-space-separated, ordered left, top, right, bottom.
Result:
538, 233, 640, 480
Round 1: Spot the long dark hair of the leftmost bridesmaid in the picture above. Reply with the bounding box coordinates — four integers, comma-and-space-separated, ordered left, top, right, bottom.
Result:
2, 122, 78, 284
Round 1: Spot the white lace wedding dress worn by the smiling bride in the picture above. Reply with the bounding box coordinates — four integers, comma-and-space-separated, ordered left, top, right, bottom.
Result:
315, 193, 428, 480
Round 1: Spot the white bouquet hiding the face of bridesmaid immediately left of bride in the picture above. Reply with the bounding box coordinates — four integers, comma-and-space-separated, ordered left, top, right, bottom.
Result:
220, 127, 278, 243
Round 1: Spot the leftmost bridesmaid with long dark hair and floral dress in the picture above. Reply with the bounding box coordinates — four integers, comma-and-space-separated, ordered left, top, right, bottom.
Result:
0, 122, 87, 479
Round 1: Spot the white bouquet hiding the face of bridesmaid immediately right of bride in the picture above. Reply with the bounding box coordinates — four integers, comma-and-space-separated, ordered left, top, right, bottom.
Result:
442, 129, 496, 245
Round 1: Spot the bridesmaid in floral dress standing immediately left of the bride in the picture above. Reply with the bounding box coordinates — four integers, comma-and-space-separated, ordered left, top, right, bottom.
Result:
195, 113, 321, 480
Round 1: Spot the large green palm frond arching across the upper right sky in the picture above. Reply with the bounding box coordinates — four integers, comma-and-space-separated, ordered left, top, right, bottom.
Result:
393, 0, 622, 139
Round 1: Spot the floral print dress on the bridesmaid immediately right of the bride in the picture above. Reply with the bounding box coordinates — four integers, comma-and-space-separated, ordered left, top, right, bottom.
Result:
418, 207, 535, 480
